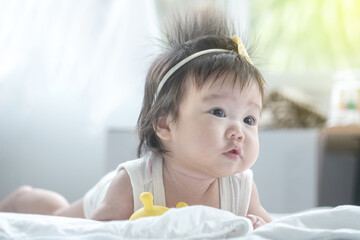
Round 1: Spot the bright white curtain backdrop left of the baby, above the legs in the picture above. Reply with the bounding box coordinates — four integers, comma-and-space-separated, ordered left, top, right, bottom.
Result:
0, 0, 157, 201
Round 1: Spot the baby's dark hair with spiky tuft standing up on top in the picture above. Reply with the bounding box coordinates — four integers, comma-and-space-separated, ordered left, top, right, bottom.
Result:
137, 6, 264, 157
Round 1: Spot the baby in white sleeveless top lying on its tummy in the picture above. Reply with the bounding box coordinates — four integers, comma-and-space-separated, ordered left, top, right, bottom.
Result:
0, 7, 271, 228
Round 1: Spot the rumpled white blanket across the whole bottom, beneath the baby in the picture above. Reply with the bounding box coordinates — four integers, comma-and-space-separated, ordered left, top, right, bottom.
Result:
0, 206, 360, 240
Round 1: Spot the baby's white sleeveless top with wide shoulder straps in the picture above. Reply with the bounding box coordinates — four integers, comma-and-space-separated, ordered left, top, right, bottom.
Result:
84, 153, 253, 218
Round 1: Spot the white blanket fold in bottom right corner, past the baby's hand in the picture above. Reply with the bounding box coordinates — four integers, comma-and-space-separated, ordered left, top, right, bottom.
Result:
236, 205, 360, 240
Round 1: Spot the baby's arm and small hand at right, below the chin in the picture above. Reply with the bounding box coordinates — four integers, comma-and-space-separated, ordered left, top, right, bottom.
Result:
247, 182, 271, 229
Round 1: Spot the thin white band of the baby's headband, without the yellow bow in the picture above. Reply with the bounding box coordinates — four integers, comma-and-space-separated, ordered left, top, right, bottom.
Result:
153, 48, 231, 104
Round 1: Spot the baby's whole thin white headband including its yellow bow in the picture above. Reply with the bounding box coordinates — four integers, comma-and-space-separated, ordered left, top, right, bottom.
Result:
153, 35, 266, 104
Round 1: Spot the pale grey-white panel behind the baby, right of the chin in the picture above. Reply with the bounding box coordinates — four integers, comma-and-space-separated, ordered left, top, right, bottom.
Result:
252, 129, 321, 213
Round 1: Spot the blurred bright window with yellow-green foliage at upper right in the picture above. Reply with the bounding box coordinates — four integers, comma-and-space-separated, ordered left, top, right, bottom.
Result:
249, 0, 360, 72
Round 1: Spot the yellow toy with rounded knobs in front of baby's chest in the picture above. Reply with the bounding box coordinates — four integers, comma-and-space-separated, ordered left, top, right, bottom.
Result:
129, 192, 187, 220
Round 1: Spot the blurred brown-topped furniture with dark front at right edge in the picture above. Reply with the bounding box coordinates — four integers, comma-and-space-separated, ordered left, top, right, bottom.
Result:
319, 126, 360, 206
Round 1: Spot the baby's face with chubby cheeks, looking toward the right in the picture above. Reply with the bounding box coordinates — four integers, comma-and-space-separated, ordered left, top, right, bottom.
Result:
167, 76, 262, 177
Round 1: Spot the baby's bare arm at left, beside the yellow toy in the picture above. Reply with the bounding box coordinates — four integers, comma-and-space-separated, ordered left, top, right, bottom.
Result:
91, 169, 134, 221
